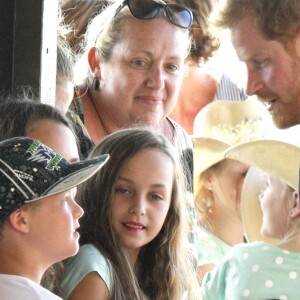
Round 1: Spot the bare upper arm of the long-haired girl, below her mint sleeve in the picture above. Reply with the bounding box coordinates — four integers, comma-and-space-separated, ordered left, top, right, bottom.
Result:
68, 272, 110, 300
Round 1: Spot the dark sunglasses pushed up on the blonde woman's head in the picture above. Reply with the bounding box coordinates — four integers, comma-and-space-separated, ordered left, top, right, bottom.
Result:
115, 0, 193, 29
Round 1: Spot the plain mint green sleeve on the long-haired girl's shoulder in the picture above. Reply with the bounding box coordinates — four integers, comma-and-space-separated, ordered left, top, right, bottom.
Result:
61, 244, 111, 299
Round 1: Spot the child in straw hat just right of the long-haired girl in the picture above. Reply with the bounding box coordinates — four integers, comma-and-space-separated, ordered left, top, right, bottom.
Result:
193, 99, 273, 282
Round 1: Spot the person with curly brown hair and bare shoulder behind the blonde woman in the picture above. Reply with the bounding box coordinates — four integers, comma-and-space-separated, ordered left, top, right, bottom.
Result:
170, 0, 219, 134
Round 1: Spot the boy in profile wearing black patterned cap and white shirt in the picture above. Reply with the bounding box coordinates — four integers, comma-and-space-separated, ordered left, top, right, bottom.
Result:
0, 137, 109, 300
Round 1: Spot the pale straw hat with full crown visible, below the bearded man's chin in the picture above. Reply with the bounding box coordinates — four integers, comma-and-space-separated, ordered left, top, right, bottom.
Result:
193, 98, 274, 195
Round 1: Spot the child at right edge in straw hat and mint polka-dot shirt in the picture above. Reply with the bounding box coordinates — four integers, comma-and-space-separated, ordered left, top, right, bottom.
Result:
202, 140, 300, 300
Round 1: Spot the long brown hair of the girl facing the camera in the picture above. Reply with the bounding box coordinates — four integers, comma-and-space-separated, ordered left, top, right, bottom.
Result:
78, 128, 199, 300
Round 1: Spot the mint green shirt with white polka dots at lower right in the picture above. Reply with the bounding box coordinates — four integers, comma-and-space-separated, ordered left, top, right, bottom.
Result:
201, 242, 300, 300
